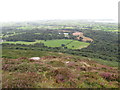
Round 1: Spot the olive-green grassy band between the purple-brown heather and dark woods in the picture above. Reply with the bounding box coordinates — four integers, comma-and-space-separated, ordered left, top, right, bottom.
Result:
2, 49, 118, 67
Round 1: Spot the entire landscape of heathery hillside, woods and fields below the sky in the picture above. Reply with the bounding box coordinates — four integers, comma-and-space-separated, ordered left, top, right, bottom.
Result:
0, 20, 119, 88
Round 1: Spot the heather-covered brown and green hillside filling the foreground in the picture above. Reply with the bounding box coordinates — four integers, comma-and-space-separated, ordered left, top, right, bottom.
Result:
2, 49, 118, 88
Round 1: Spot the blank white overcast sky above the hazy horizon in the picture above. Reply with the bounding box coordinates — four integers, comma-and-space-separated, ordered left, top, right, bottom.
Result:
0, 0, 119, 22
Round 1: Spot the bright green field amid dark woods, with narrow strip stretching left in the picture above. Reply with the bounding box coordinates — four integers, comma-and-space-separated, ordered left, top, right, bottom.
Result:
3, 39, 90, 49
